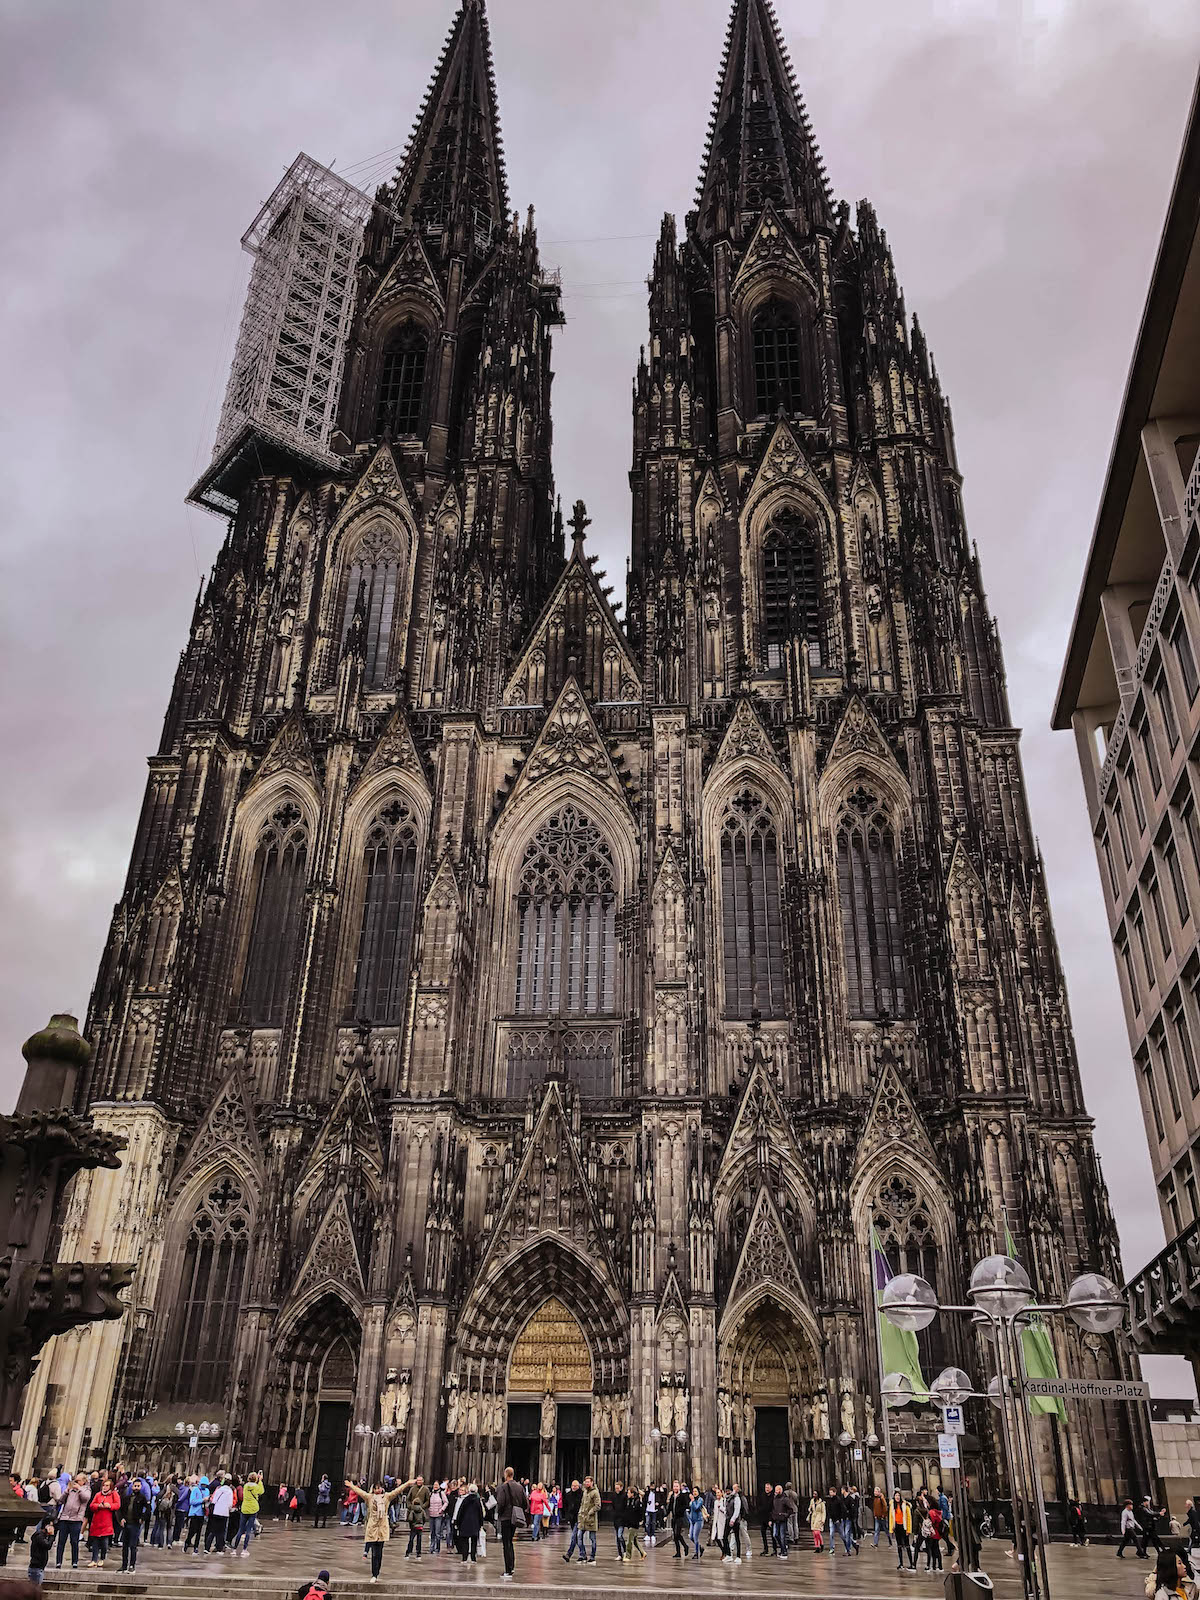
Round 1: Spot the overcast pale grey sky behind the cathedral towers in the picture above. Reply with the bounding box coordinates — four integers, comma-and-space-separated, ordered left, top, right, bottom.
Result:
0, 0, 1200, 1388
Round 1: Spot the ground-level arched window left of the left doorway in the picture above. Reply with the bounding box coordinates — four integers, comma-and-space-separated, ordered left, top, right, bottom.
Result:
171, 1174, 250, 1402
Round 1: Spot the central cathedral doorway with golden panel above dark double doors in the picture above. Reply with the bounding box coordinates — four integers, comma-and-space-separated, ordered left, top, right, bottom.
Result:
506, 1294, 594, 1483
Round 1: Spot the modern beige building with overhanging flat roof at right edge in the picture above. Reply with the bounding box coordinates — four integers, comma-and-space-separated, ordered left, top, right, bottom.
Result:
1054, 68, 1200, 1388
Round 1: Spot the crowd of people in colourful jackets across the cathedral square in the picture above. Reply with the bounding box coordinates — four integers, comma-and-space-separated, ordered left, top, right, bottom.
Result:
11, 1467, 1200, 1600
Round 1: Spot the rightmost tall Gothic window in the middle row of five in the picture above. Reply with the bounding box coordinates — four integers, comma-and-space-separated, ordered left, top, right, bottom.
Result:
837, 789, 907, 1018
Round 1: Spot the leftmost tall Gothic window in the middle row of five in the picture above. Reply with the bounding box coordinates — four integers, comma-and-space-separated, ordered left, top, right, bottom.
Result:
237, 802, 309, 1027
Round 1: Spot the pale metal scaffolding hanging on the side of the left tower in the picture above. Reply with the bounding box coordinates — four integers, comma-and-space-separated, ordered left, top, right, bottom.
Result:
187, 154, 374, 515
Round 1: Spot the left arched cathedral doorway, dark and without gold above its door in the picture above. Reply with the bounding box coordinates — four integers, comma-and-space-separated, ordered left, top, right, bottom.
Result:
274, 1293, 362, 1499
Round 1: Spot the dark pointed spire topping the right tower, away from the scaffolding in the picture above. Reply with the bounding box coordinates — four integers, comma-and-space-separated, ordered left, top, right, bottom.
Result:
696, 0, 834, 238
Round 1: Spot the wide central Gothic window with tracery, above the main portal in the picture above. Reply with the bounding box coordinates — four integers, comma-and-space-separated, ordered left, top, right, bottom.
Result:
515, 805, 616, 1016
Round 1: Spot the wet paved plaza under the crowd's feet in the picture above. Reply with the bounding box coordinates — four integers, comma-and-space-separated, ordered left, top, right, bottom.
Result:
32, 1522, 1147, 1600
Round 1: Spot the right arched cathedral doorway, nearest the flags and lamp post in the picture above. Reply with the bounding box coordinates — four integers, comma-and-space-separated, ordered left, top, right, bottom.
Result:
717, 1293, 829, 1493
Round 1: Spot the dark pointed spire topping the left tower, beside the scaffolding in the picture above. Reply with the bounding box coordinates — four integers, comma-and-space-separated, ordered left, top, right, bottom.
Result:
392, 0, 509, 248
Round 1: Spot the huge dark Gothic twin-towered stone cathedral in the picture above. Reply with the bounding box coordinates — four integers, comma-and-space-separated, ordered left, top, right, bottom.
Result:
18, 0, 1150, 1502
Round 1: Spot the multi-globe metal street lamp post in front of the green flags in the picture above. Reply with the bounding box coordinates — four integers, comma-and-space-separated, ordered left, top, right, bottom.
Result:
880, 1256, 1125, 1600
